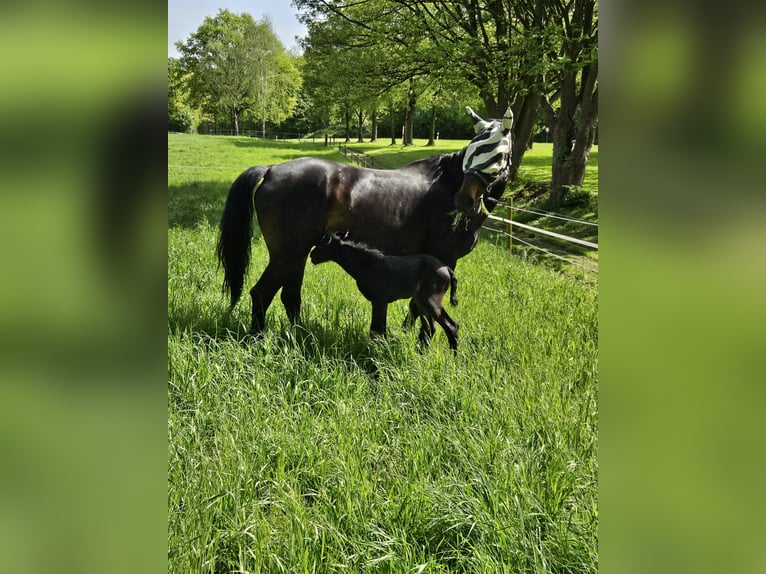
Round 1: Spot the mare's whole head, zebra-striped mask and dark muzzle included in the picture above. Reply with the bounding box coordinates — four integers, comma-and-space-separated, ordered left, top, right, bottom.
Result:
455, 106, 513, 215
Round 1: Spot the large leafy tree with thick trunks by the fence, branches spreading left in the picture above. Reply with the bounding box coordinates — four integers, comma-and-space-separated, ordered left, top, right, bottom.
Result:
294, 0, 598, 207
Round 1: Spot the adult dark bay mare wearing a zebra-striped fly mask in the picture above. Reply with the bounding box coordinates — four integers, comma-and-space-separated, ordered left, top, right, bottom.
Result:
217, 108, 512, 333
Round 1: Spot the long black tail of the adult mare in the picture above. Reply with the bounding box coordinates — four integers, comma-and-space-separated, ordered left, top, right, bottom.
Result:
216, 166, 271, 308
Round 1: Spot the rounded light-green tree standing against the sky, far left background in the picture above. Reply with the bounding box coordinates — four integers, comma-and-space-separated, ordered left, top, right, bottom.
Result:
176, 10, 300, 135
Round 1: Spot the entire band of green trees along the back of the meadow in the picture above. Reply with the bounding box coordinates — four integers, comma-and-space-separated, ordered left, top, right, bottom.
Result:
171, 0, 598, 204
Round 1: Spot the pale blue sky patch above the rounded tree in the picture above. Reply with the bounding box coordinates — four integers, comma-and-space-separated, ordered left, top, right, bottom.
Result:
168, 0, 306, 58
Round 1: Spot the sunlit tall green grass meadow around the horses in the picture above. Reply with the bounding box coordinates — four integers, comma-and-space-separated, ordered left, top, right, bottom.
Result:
168, 134, 598, 573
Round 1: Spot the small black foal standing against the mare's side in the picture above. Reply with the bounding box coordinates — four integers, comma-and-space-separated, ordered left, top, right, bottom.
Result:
311, 233, 458, 353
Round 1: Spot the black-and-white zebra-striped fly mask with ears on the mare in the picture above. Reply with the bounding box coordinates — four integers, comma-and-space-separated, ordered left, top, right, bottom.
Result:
463, 106, 513, 174
